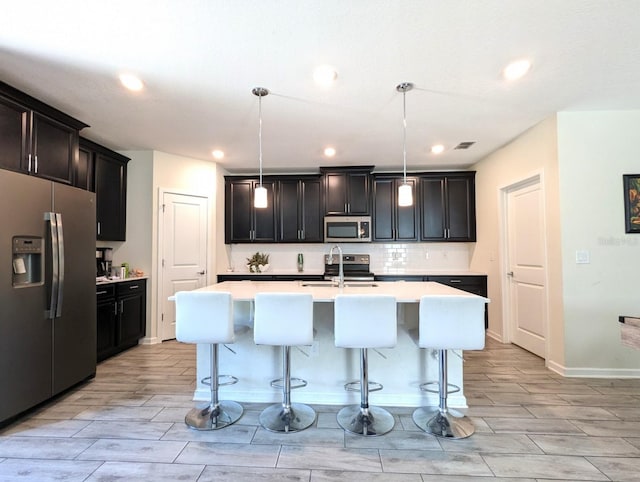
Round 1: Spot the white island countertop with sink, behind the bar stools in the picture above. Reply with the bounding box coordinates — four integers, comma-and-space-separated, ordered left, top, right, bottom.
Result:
188, 281, 489, 303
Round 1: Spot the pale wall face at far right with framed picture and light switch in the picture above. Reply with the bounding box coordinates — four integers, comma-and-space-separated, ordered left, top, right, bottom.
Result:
558, 111, 640, 376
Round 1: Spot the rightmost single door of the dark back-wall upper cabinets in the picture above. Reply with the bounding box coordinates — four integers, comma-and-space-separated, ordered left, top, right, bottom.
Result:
446, 176, 476, 241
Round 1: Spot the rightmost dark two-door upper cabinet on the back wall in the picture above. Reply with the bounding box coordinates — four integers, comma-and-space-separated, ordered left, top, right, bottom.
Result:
419, 171, 476, 242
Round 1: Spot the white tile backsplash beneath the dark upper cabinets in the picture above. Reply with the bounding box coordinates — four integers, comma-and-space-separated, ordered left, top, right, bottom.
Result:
224, 243, 470, 274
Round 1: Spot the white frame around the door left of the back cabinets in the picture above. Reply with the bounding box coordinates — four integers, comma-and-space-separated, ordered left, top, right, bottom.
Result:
155, 187, 214, 343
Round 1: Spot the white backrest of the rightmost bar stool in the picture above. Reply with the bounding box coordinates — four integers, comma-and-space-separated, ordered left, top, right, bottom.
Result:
418, 296, 485, 350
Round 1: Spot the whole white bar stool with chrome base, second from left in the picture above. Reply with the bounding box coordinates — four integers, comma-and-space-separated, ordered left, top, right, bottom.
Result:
253, 293, 316, 432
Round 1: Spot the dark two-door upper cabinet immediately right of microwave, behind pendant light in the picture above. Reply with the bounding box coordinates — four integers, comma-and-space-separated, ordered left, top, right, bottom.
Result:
373, 175, 419, 241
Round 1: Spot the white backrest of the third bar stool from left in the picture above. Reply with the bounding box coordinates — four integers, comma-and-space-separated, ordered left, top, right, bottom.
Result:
334, 295, 398, 348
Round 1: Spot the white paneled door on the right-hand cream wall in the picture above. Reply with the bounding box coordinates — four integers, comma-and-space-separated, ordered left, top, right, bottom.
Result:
506, 176, 547, 358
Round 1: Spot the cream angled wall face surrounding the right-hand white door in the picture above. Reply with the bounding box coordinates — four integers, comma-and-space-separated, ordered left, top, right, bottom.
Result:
470, 117, 564, 366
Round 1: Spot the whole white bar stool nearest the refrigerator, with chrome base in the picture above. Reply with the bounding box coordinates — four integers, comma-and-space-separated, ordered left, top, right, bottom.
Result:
175, 291, 243, 430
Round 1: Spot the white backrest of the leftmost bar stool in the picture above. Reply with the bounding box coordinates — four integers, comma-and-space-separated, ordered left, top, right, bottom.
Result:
175, 291, 234, 344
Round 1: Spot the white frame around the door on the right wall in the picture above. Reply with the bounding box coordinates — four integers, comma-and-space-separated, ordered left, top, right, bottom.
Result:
498, 169, 550, 358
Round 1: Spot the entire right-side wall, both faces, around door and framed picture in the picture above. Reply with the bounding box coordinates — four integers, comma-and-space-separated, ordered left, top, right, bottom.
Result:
470, 111, 640, 376
